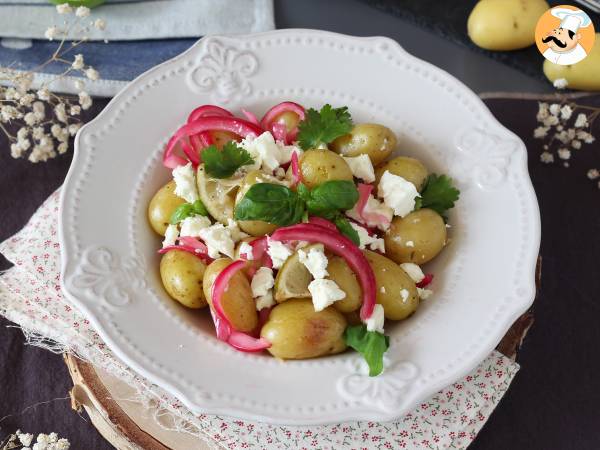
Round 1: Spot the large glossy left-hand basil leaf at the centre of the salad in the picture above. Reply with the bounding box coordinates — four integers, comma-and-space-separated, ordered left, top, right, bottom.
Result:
235, 183, 305, 226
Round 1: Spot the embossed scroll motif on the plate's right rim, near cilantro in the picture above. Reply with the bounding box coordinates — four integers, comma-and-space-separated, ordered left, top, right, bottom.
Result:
448, 128, 519, 189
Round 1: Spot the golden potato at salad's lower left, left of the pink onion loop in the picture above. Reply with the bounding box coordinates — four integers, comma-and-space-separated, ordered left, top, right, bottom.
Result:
160, 250, 207, 309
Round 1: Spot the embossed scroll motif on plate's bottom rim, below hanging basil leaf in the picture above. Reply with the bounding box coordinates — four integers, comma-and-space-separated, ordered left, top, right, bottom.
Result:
337, 356, 419, 412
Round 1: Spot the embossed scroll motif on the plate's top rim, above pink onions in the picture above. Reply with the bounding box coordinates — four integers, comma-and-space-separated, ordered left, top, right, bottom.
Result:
188, 40, 258, 103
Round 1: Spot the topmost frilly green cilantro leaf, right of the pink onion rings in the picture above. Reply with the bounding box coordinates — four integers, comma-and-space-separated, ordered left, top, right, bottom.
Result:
298, 104, 352, 150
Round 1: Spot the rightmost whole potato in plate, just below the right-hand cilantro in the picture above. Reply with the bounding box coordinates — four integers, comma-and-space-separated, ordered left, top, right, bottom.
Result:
384, 208, 446, 265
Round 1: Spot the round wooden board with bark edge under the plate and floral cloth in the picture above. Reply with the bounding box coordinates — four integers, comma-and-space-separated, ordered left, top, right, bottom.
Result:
64, 258, 541, 450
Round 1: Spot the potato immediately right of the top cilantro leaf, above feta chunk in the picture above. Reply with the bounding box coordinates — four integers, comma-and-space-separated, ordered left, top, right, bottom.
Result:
330, 123, 397, 166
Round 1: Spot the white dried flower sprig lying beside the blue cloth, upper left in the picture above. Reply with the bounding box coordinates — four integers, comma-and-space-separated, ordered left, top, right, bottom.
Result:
0, 3, 106, 163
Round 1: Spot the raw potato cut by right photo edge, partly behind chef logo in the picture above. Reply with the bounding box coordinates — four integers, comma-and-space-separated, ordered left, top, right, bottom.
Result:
544, 33, 600, 91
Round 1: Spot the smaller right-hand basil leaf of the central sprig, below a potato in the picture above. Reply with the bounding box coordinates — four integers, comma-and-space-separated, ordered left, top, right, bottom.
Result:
306, 180, 358, 217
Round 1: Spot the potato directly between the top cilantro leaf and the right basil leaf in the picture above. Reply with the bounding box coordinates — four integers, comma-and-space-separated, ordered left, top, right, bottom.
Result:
300, 149, 353, 188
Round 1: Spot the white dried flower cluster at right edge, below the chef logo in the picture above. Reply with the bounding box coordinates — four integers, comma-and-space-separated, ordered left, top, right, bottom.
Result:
533, 101, 600, 183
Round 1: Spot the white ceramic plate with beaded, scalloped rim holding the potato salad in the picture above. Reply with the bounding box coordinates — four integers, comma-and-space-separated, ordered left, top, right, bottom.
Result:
60, 30, 540, 424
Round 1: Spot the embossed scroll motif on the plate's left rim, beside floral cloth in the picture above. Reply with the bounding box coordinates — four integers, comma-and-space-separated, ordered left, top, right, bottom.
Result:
70, 246, 144, 306
